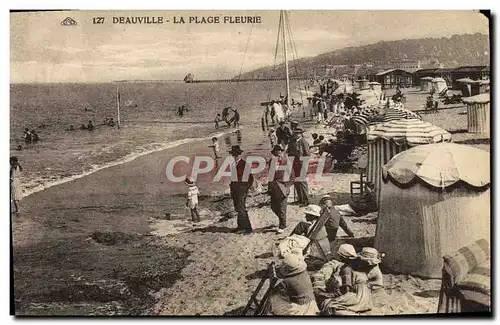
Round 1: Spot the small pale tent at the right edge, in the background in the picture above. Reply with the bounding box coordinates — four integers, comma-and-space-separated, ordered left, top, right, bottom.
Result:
463, 93, 490, 135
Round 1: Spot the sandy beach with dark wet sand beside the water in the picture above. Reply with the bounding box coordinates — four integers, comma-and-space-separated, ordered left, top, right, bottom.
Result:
13, 86, 489, 315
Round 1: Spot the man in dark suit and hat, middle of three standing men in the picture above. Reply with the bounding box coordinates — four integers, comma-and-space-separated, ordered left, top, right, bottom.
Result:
268, 144, 290, 234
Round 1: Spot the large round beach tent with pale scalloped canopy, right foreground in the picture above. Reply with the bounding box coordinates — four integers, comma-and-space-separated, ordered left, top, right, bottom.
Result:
374, 143, 490, 278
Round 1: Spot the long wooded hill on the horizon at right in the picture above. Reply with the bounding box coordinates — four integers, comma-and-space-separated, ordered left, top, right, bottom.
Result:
241, 33, 490, 79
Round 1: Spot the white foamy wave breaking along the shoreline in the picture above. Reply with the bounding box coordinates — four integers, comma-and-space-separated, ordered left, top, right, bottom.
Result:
23, 126, 243, 197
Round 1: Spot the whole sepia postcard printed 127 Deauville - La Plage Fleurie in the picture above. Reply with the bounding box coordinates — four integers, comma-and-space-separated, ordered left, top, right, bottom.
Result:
10, 10, 492, 317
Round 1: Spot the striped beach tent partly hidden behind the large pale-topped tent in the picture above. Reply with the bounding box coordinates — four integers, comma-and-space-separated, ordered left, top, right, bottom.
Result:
367, 118, 451, 202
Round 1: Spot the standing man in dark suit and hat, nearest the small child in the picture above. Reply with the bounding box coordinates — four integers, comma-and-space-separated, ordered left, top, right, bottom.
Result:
229, 145, 254, 234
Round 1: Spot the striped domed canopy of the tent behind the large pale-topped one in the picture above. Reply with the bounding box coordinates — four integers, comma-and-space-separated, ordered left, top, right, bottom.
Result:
367, 118, 451, 146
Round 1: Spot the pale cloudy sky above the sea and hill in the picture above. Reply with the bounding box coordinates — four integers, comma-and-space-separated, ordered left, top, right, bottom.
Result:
10, 10, 488, 83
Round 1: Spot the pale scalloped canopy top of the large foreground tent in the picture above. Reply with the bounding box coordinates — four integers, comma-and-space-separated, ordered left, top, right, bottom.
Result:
382, 143, 491, 188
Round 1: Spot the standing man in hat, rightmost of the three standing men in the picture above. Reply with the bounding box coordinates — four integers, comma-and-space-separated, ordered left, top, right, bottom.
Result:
288, 128, 311, 206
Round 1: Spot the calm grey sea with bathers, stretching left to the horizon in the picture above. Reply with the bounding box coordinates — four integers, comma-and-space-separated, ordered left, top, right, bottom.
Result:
10, 81, 307, 196
